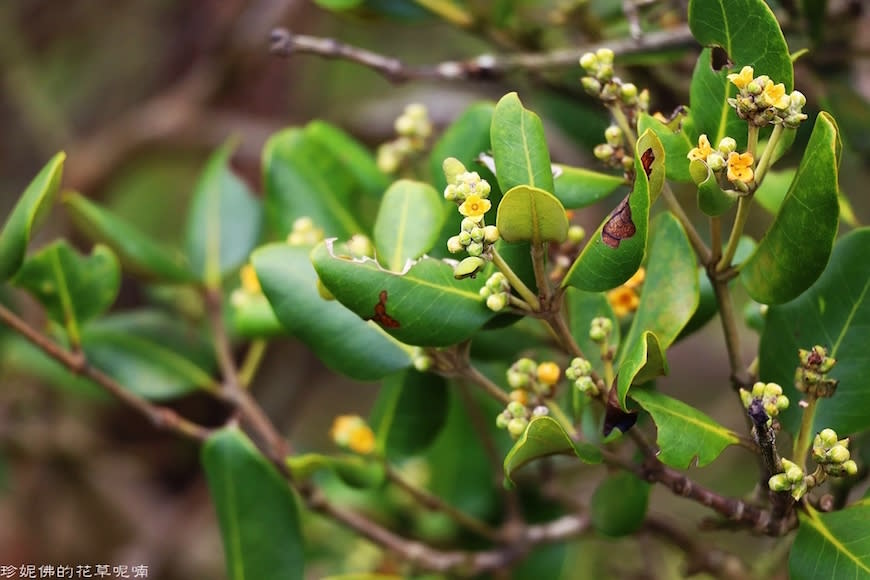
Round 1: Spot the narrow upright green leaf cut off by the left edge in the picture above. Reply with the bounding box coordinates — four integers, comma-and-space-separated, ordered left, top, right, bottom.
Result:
0, 152, 66, 282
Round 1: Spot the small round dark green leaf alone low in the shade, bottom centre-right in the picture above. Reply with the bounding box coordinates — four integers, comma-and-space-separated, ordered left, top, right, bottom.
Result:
589, 472, 651, 538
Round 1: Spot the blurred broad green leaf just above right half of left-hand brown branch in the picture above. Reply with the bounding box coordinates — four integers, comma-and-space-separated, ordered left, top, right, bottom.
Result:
81, 311, 215, 400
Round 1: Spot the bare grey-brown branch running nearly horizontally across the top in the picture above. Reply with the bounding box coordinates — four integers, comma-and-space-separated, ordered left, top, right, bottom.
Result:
271, 25, 694, 83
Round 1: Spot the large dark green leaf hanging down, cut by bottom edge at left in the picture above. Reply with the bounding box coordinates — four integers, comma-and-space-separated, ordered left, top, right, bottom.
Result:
202, 428, 305, 580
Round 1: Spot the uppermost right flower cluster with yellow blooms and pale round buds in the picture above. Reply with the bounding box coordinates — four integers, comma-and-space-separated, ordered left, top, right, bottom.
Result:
728, 66, 807, 129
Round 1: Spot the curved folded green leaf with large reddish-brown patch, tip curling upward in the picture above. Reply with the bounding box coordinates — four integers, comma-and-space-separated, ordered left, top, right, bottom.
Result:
562, 130, 664, 292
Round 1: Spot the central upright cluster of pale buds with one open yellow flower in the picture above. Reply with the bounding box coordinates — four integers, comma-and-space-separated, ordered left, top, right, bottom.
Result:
443, 157, 507, 278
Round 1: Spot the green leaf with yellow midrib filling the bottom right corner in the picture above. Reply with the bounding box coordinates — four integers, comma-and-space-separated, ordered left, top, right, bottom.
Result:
788, 505, 870, 580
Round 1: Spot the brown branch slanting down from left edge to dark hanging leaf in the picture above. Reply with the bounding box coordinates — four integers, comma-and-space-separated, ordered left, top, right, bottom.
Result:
0, 304, 212, 441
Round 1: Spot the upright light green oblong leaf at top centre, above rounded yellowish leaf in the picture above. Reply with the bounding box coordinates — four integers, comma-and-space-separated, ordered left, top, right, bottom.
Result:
490, 93, 553, 193
